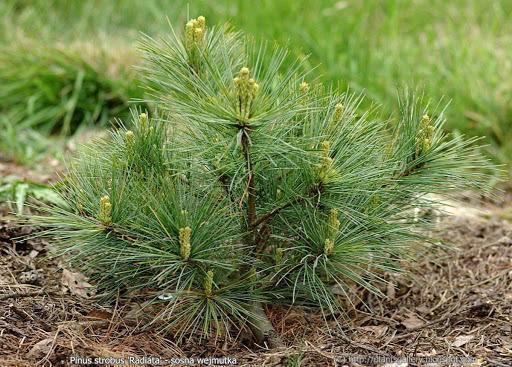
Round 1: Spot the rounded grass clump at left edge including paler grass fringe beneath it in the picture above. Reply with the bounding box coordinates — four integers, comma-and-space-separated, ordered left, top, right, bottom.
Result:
0, 41, 142, 163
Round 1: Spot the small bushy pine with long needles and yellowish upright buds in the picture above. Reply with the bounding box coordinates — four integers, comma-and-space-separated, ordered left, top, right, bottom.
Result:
33, 17, 485, 344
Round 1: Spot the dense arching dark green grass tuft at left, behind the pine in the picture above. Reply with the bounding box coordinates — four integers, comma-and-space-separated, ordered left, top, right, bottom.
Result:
0, 43, 141, 140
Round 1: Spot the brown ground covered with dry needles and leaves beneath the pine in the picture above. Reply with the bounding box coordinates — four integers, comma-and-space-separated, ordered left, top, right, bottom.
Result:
0, 162, 512, 367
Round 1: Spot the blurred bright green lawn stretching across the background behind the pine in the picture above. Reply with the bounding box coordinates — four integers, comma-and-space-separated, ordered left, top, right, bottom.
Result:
0, 0, 512, 175
